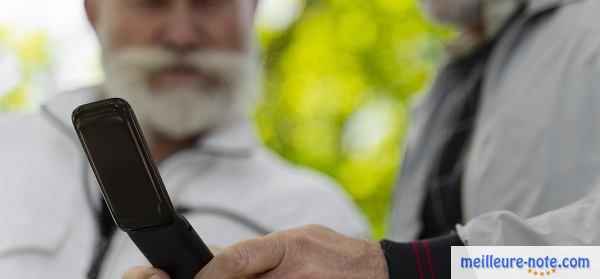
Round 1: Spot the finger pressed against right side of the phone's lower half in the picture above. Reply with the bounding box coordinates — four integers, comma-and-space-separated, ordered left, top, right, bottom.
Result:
195, 236, 285, 279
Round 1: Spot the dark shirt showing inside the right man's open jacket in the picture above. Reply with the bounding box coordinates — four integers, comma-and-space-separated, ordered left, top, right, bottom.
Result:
419, 46, 491, 238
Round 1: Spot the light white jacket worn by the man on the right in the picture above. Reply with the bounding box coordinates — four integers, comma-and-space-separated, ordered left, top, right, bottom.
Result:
391, 0, 600, 245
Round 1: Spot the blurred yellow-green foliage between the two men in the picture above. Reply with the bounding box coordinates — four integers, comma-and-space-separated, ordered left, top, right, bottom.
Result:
255, 0, 451, 237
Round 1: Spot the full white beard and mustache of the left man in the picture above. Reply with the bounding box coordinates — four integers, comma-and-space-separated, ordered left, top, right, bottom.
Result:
102, 48, 260, 142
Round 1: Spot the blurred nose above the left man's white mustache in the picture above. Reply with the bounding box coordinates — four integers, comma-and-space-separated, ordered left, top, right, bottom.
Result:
162, 1, 202, 53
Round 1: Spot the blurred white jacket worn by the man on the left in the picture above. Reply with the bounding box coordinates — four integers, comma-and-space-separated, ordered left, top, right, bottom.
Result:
0, 89, 369, 279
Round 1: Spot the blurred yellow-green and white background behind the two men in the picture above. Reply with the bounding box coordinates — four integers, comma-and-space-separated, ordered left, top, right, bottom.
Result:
0, 0, 451, 237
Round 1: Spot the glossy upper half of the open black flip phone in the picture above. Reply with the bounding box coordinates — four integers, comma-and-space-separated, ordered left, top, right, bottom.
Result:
72, 98, 176, 231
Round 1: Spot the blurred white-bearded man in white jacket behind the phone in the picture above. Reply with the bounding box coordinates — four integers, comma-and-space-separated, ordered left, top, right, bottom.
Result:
0, 0, 370, 279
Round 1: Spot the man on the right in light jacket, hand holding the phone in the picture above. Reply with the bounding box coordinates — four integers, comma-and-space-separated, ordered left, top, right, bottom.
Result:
125, 0, 600, 279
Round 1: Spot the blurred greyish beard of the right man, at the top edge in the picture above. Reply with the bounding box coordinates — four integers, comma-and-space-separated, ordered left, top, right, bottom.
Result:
421, 0, 485, 27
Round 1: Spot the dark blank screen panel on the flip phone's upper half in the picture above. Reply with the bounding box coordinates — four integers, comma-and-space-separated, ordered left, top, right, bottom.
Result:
78, 103, 172, 230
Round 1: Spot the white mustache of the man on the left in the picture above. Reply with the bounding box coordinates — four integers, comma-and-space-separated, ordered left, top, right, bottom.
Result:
102, 48, 252, 81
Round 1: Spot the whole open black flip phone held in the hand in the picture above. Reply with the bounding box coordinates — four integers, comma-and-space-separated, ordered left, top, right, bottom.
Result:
72, 98, 213, 279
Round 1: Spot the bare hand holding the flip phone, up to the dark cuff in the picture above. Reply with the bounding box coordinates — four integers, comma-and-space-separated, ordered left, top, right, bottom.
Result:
197, 226, 388, 279
